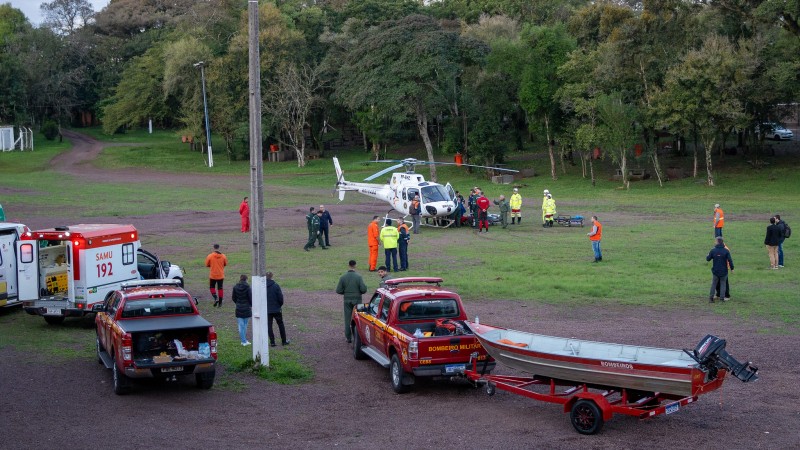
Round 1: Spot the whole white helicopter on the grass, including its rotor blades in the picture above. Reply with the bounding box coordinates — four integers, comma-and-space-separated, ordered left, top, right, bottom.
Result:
333, 157, 518, 228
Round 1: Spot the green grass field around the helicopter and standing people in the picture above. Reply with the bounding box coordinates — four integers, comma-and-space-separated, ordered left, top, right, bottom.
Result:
0, 130, 800, 379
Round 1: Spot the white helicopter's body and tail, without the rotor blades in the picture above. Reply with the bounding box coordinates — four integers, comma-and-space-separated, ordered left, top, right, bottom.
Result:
334, 158, 456, 218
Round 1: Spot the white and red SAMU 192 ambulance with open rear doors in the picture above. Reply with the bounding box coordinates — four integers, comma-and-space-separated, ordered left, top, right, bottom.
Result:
16, 224, 183, 324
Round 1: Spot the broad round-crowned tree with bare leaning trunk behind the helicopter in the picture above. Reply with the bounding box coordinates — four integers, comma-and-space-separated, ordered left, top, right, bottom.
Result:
335, 15, 476, 181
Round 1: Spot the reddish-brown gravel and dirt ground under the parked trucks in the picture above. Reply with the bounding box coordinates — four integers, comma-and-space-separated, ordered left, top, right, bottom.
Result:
0, 132, 800, 449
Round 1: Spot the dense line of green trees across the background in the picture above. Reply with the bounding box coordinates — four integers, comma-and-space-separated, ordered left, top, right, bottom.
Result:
0, 0, 800, 186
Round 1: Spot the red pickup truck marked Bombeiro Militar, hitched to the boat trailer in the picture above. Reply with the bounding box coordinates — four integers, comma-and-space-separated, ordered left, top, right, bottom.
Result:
350, 277, 495, 394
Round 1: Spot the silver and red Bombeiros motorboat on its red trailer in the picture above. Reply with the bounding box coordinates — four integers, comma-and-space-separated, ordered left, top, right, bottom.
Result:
464, 321, 758, 434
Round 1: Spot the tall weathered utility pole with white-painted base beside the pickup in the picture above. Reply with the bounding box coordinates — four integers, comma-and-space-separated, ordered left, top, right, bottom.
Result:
247, 0, 269, 366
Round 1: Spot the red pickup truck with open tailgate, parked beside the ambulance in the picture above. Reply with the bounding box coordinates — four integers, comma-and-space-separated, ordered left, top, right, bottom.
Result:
92, 280, 217, 394
